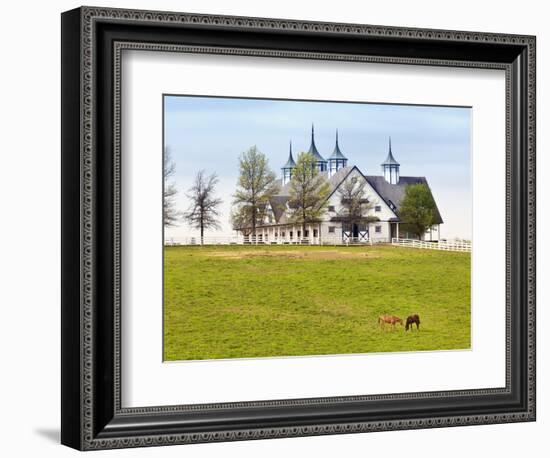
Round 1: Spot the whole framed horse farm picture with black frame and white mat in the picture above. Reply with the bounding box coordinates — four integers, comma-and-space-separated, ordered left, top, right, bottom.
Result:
61, 7, 536, 450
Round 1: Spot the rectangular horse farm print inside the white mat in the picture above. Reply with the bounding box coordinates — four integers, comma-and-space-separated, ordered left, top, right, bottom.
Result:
163, 94, 472, 361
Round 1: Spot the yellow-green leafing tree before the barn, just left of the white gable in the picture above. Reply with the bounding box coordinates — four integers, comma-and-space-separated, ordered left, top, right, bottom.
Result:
288, 153, 330, 237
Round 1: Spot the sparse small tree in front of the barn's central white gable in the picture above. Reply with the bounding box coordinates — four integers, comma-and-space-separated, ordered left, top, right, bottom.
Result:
336, 177, 379, 234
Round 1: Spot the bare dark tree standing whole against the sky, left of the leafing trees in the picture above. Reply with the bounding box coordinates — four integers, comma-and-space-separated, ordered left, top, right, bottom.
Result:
183, 170, 222, 245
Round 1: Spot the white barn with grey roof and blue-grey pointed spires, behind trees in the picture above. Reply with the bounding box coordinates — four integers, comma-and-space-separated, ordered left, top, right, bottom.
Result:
247, 126, 443, 244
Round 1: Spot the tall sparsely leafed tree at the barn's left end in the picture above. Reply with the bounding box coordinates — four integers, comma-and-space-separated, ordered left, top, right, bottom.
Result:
232, 146, 279, 235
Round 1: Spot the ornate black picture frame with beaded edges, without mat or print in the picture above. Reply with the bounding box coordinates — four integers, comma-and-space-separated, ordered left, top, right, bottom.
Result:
61, 7, 535, 450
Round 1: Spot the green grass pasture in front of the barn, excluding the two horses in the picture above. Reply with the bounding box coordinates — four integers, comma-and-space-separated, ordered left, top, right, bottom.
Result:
163, 246, 470, 361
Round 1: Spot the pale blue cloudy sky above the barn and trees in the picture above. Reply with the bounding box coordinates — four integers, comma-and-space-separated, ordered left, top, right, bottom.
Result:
164, 95, 472, 240
